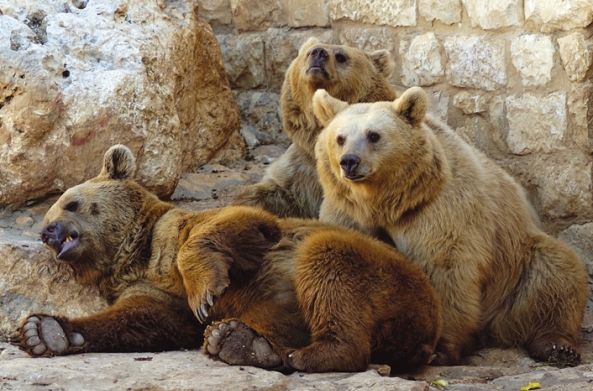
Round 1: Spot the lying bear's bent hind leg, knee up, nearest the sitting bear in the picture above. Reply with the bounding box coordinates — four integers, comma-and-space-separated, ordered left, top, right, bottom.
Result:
289, 231, 375, 372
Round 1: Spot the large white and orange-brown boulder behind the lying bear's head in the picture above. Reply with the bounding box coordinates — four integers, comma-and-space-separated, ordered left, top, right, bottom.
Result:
0, 0, 240, 207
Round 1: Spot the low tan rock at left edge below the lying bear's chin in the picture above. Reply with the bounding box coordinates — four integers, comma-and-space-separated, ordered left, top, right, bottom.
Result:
0, 230, 106, 336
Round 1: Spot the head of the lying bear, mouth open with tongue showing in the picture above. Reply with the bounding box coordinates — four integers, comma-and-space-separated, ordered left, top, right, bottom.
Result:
41, 145, 166, 282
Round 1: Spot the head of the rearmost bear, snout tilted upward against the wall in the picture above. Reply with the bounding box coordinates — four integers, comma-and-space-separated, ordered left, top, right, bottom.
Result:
287, 38, 395, 103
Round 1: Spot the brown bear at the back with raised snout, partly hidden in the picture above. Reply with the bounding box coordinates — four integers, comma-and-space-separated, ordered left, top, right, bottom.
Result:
234, 38, 396, 218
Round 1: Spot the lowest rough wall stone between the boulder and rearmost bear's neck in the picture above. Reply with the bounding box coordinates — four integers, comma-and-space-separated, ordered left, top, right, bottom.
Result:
235, 91, 290, 146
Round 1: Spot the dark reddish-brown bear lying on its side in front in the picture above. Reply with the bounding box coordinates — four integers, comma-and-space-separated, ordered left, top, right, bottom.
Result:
16, 146, 441, 372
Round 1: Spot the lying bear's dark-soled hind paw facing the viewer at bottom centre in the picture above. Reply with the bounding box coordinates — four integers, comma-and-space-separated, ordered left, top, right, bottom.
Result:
204, 320, 282, 368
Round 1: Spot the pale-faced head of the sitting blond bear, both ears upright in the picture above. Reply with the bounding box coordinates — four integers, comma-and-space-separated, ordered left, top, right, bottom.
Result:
313, 87, 428, 184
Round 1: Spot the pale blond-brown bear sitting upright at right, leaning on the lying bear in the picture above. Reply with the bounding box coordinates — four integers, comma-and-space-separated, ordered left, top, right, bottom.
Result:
313, 87, 587, 365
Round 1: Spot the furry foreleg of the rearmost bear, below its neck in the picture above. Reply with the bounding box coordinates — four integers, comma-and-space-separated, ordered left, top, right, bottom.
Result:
233, 144, 323, 218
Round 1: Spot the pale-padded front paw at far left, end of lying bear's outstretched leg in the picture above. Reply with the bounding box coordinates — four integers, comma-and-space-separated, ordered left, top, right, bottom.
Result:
19, 315, 85, 357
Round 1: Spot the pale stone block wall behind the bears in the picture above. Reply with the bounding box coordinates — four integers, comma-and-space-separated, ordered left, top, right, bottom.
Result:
199, 0, 593, 294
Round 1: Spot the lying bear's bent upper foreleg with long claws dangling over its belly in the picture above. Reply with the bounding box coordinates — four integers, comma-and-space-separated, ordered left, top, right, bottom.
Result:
177, 206, 282, 323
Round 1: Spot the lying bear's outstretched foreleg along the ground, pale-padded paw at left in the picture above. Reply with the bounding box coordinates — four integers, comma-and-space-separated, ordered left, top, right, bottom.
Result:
15, 296, 202, 357
